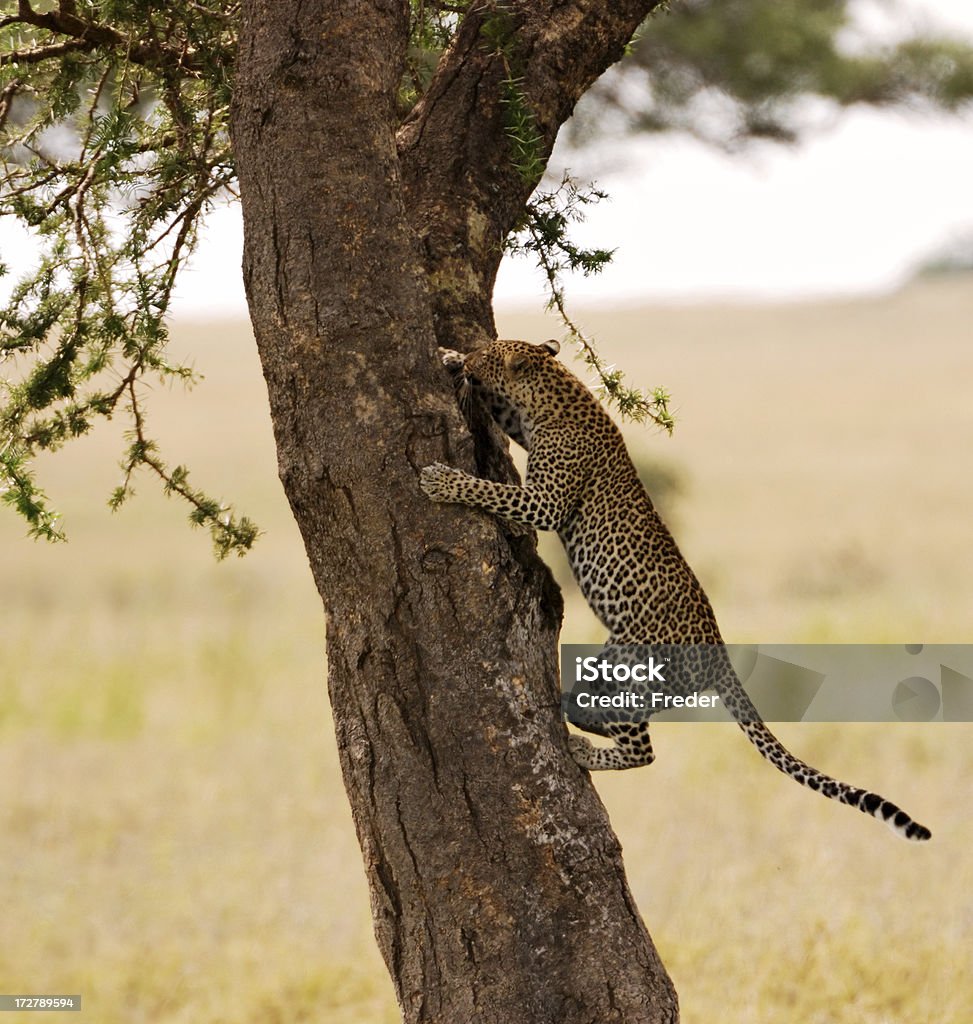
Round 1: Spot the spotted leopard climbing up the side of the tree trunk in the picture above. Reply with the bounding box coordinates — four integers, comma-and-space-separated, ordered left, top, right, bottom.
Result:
419, 339, 932, 842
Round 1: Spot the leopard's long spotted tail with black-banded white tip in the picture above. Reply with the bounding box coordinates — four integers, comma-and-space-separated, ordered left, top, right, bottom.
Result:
715, 674, 932, 842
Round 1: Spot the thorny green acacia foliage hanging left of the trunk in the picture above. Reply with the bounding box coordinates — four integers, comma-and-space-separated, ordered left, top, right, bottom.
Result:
0, 0, 250, 556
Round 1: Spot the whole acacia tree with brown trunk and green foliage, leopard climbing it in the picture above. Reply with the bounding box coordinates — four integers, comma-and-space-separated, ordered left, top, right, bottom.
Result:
0, 0, 970, 1024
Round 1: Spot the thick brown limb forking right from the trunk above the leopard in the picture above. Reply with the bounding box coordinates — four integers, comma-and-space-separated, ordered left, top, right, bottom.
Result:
397, 0, 661, 348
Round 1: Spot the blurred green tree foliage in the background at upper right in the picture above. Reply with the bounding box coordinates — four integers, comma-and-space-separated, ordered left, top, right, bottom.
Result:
573, 0, 973, 150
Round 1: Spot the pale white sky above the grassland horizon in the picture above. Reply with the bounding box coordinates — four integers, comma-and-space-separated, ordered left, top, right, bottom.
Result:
0, 0, 973, 316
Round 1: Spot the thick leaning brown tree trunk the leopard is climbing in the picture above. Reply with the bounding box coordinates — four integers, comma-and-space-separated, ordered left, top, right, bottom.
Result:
234, 0, 678, 1024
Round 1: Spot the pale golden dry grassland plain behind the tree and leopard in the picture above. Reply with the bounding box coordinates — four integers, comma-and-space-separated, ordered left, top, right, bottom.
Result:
0, 280, 973, 1024
